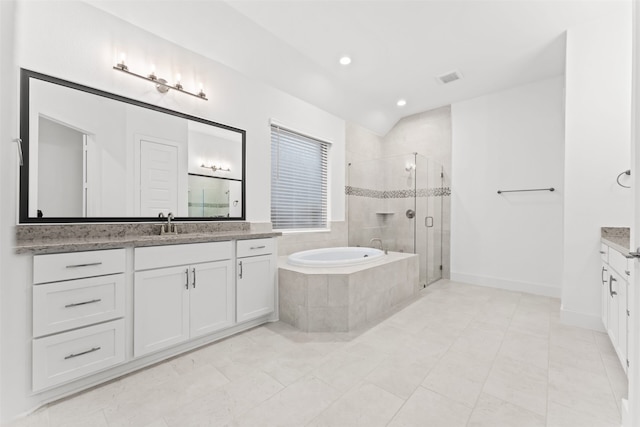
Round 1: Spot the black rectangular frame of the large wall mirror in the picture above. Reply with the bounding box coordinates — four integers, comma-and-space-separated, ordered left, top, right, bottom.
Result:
19, 68, 247, 224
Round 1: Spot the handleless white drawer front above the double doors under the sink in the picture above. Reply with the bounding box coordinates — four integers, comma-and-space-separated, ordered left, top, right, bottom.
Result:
135, 242, 233, 270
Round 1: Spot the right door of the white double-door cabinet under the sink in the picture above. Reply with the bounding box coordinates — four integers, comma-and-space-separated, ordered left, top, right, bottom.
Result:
189, 260, 234, 338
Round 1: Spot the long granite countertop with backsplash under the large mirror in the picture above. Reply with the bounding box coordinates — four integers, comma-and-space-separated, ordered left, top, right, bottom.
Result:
15, 223, 282, 254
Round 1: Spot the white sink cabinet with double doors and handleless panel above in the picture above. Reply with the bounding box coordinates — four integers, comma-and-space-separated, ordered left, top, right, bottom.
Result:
133, 242, 234, 357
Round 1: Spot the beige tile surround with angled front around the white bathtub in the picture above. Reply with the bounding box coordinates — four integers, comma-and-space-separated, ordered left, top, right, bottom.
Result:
278, 252, 418, 332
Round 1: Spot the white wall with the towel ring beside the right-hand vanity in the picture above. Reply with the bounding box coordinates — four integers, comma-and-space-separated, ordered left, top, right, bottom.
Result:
562, 4, 632, 328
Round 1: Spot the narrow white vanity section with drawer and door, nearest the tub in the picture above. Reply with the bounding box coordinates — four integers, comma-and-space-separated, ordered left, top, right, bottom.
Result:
236, 238, 277, 322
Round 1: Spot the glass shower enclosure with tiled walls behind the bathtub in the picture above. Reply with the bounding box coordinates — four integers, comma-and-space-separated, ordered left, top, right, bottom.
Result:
346, 153, 443, 286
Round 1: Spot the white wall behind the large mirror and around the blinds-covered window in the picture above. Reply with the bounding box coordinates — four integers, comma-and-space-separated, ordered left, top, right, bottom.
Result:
0, 0, 345, 420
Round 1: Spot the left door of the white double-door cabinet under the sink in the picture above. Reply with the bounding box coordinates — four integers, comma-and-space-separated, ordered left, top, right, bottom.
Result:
133, 266, 189, 357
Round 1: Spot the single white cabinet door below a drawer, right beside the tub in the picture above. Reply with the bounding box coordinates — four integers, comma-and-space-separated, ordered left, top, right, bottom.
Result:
236, 255, 275, 322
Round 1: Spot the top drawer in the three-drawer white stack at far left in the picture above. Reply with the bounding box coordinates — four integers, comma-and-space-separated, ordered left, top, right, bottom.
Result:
33, 249, 125, 284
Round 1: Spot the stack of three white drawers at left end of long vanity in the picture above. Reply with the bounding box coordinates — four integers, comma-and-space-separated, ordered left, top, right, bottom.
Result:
32, 249, 125, 391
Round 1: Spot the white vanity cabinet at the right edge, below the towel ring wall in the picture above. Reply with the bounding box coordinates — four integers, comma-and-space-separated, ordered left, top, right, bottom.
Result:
600, 245, 631, 372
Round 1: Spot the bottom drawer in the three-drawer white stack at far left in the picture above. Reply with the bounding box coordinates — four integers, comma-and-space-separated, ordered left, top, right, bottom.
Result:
33, 319, 124, 391
